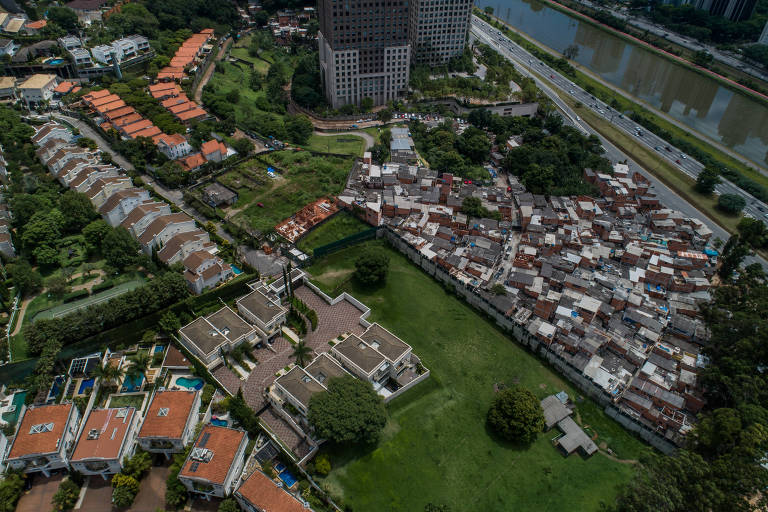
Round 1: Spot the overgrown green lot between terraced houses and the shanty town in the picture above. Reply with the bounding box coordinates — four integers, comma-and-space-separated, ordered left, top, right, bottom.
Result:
232, 151, 353, 232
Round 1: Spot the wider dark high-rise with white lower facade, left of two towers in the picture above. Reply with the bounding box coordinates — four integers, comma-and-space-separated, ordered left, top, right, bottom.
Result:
318, 0, 411, 108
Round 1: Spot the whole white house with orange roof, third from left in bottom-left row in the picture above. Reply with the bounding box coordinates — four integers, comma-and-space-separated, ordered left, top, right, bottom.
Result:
138, 390, 200, 457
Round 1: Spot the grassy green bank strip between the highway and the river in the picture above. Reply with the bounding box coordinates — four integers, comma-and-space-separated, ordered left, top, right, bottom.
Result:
475, 9, 768, 200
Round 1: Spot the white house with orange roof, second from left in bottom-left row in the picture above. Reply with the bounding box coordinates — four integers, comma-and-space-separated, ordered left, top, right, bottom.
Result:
70, 407, 139, 480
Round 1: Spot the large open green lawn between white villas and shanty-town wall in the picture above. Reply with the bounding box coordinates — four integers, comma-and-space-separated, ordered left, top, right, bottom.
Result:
308, 242, 649, 512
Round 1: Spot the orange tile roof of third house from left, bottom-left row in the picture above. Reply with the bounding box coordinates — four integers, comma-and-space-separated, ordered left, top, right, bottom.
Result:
139, 390, 198, 439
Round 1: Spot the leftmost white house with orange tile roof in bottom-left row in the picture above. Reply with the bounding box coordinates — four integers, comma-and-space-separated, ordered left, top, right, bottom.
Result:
5, 403, 80, 476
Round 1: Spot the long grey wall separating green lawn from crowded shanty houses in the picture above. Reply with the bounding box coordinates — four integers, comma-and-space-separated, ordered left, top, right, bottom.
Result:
381, 227, 677, 454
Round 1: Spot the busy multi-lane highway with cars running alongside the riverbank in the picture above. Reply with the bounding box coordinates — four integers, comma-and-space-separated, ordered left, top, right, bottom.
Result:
472, 16, 768, 223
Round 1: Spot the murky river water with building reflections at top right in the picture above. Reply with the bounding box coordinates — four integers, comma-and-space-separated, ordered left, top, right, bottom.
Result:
476, 0, 768, 167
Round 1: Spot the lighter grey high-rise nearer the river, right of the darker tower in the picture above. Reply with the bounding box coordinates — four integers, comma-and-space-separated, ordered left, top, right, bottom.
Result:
408, 0, 472, 65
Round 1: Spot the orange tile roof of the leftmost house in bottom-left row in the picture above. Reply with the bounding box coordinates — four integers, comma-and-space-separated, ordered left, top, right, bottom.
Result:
8, 404, 74, 459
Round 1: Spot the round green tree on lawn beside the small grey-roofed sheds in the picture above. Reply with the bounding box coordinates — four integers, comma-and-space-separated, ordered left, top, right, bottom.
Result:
487, 386, 544, 444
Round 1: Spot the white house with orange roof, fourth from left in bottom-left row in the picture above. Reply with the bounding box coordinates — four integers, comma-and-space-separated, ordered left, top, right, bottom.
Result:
179, 425, 248, 498
